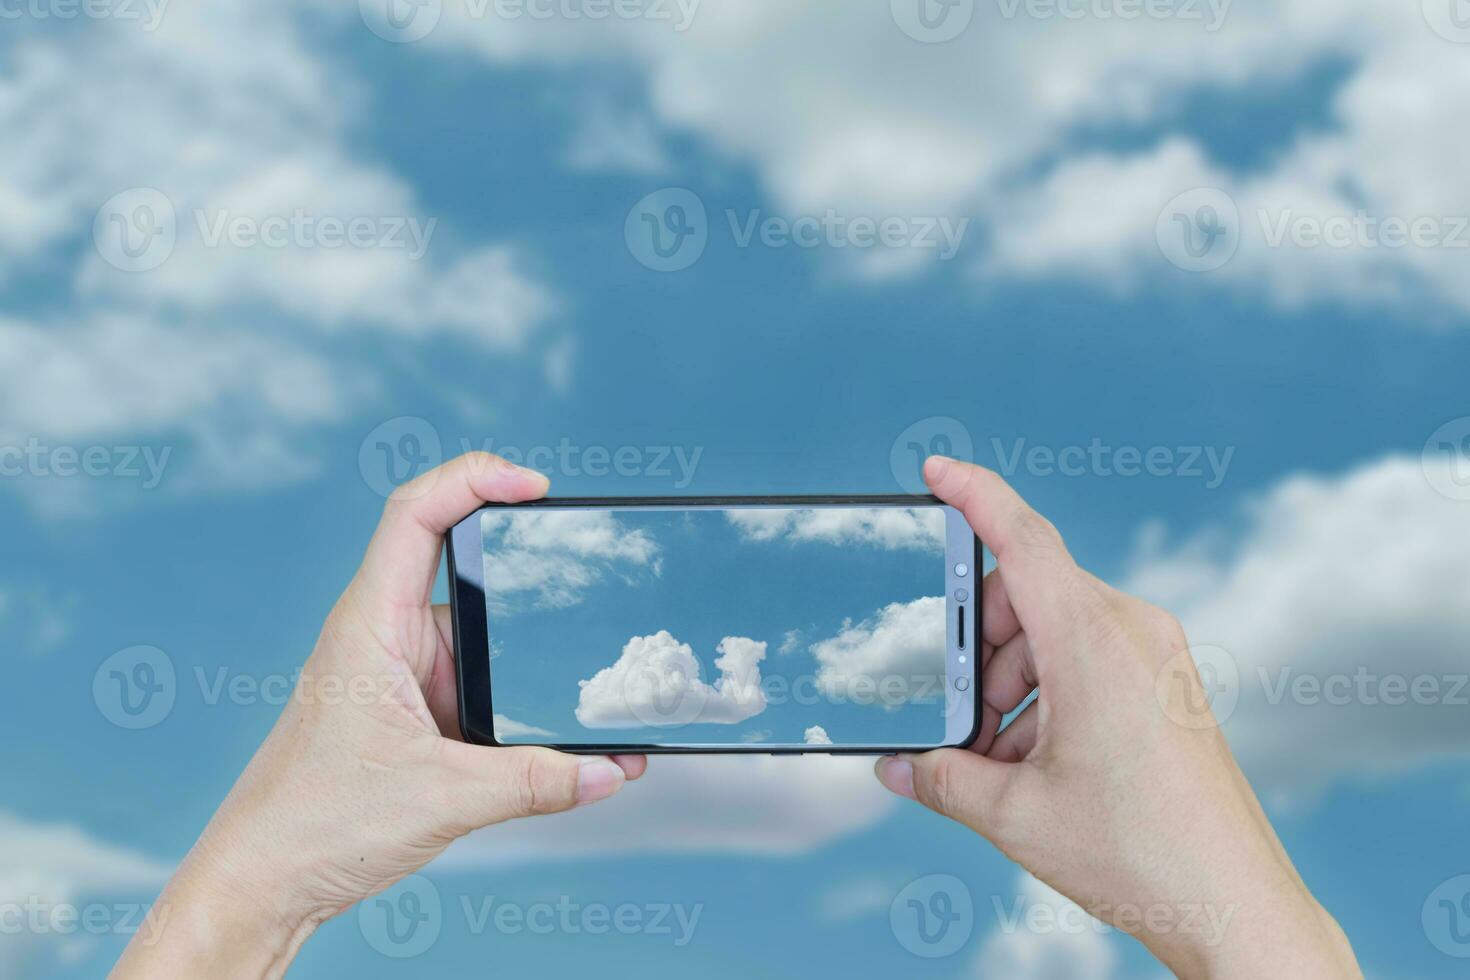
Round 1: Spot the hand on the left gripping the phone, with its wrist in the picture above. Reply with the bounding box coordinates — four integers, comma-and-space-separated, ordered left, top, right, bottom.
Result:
116, 453, 645, 977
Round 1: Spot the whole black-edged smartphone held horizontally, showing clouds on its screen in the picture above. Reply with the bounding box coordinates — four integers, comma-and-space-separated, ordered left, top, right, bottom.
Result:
447, 495, 982, 755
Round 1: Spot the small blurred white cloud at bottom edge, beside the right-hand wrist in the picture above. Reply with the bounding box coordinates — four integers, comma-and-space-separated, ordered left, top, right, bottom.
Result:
976, 871, 1119, 980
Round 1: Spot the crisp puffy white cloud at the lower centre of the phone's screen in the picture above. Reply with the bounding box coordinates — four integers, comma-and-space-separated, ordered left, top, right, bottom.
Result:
576, 630, 766, 729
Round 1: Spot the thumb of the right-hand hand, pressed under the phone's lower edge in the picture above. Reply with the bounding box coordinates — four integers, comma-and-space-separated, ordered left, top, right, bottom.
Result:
878, 749, 1022, 843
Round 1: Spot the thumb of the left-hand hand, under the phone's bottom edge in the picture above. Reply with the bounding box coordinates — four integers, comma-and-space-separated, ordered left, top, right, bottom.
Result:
444, 742, 626, 830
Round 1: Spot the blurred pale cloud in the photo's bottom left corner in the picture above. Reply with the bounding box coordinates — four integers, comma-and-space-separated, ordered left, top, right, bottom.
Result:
0, 811, 172, 977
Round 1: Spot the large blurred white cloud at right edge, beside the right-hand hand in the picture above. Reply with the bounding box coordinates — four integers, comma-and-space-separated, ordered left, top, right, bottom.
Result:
1127, 457, 1470, 802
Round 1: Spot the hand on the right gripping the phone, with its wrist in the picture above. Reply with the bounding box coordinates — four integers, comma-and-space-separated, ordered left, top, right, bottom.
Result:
878, 457, 1360, 977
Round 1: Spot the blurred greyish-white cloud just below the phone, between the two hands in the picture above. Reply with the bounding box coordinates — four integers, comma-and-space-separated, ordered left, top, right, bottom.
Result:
445, 755, 897, 864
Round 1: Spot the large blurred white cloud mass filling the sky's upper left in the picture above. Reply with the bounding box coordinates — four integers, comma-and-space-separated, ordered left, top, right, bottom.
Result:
0, 0, 556, 508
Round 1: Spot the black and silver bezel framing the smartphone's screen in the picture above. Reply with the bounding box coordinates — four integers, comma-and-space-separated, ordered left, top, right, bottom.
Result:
444, 494, 985, 755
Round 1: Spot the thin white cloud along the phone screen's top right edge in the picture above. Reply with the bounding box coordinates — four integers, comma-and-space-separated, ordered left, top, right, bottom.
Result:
725, 507, 944, 551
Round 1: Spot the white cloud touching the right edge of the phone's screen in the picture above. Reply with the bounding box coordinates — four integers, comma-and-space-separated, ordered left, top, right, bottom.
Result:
811, 595, 945, 707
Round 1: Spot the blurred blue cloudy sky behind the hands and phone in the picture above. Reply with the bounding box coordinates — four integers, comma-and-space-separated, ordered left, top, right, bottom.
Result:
0, 0, 1470, 977
